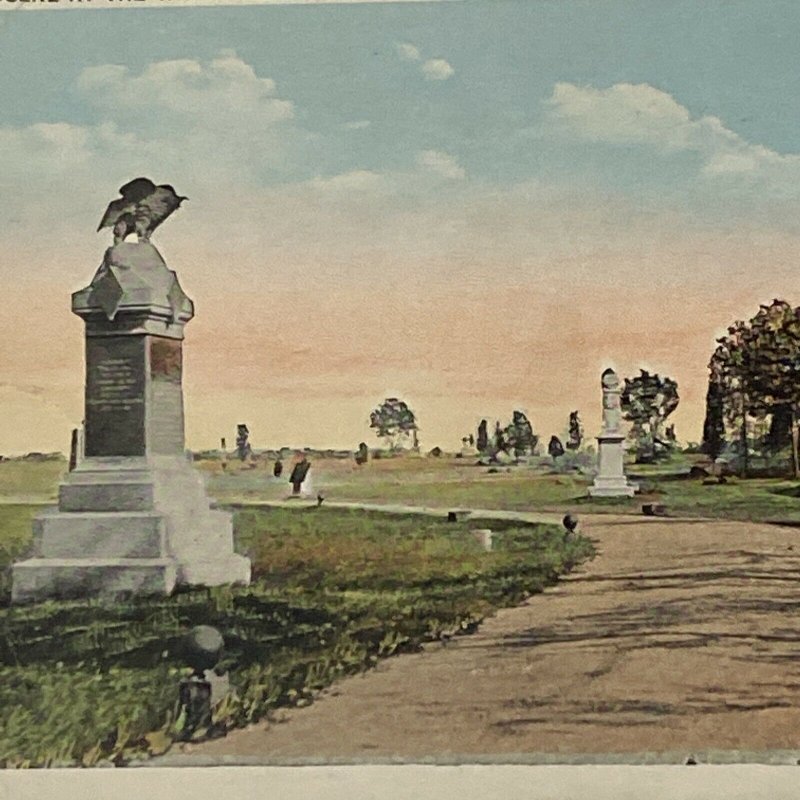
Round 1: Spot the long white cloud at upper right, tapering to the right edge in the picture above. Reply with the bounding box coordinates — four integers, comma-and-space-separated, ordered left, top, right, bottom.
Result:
547, 83, 800, 174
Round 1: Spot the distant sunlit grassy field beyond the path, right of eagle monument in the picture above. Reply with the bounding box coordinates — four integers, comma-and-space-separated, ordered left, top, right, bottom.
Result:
200, 458, 800, 522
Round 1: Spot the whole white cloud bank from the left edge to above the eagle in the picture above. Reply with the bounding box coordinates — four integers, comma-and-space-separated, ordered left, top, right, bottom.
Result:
0, 52, 309, 244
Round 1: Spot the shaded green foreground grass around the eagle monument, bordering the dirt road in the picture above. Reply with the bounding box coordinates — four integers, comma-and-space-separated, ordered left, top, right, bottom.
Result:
0, 506, 592, 766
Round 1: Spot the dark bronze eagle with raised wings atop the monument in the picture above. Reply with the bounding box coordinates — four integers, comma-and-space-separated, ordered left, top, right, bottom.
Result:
97, 178, 189, 244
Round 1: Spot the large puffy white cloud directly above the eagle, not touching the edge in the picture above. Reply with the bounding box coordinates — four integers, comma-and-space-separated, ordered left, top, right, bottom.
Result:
48, 50, 310, 188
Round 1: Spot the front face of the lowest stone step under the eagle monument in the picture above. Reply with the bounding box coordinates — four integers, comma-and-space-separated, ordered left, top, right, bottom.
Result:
11, 558, 177, 603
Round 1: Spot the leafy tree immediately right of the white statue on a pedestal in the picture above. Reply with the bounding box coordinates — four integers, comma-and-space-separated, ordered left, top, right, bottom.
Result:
621, 370, 680, 461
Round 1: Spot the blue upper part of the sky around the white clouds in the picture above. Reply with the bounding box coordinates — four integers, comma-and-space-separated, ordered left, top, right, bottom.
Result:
6, 0, 800, 186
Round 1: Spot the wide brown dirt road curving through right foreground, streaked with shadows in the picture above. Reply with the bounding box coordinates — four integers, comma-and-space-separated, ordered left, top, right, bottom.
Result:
184, 512, 800, 759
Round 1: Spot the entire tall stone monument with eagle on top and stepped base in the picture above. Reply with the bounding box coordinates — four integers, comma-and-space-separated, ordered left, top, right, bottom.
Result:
12, 179, 250, 602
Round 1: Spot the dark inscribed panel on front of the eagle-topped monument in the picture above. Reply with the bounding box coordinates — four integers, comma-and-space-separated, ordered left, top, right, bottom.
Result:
86, 336, 145, 456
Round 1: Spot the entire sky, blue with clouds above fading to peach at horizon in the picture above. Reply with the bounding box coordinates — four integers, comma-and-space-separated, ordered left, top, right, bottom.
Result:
0, 0, 800, 454
